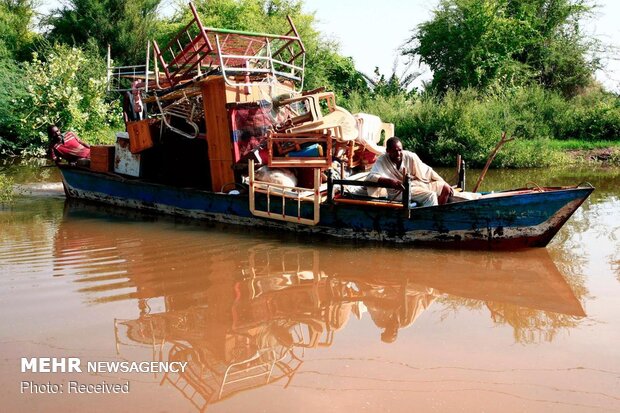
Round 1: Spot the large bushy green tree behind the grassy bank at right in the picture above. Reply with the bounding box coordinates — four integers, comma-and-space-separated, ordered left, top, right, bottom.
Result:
403, 0, 598, 96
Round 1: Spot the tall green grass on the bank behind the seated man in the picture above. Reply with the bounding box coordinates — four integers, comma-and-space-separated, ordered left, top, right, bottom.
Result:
346, 87, 620, 168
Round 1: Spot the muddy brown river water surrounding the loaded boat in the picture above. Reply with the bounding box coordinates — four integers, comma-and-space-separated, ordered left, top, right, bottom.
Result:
0, 159, 620, 413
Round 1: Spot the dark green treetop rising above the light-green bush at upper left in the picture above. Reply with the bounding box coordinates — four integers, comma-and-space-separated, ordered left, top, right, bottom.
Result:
46, 0, 161, 64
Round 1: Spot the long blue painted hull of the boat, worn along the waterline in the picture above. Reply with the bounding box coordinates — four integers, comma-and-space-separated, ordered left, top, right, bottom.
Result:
61, 166, 593, 249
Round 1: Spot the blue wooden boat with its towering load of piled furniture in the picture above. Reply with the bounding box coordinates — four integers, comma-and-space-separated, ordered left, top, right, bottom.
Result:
60, 3, 593, 249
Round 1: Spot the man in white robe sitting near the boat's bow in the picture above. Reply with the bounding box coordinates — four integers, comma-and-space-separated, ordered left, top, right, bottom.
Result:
367, 137, 454, 206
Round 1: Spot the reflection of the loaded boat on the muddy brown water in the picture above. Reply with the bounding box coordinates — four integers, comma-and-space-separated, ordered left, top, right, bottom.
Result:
55, 200, 585, 410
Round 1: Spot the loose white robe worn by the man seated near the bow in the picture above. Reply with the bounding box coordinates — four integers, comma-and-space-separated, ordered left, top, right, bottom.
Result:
367, 151, 445, 206
